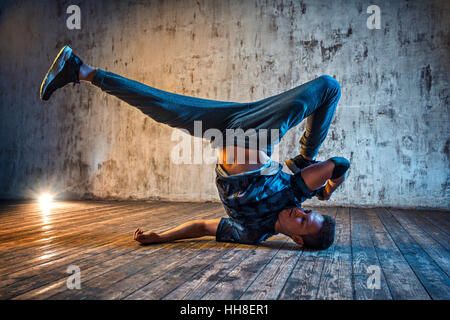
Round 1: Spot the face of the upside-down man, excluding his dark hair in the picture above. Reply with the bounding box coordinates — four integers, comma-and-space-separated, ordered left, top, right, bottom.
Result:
279, 208, 324, 236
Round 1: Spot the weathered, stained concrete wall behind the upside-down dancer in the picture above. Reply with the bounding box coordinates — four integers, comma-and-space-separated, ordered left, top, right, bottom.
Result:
0, 0, 450, 208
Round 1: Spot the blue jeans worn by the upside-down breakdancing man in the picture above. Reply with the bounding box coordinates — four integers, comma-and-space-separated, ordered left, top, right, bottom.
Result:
92, 69, 341, 158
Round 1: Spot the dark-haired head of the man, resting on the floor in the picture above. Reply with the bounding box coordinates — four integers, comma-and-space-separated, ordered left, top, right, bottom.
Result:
277, 207, 336, 250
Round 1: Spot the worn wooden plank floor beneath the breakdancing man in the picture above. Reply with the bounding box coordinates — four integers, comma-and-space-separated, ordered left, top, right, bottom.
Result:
0, 201, 450, 300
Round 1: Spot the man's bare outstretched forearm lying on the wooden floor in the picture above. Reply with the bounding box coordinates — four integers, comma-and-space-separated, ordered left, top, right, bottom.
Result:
134, 218, 221, 243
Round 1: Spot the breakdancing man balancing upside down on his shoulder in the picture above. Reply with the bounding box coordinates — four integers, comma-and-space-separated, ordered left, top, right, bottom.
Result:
41, 46, 350, 249
